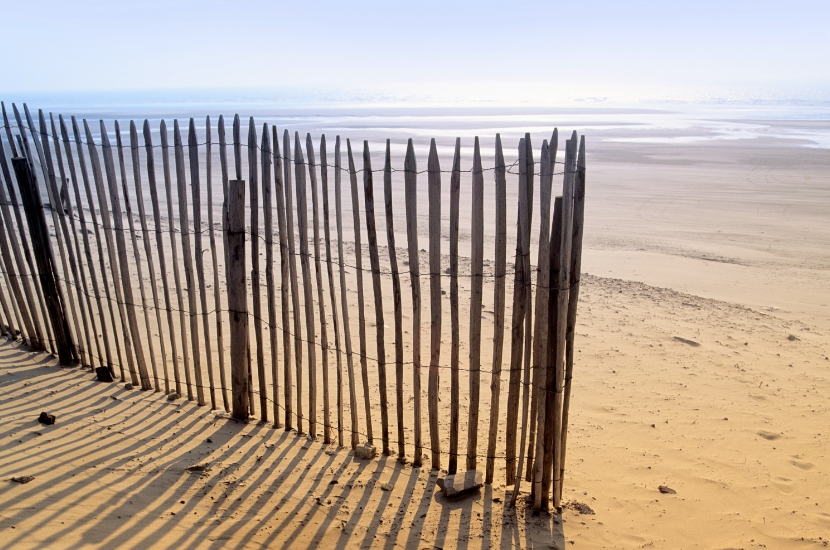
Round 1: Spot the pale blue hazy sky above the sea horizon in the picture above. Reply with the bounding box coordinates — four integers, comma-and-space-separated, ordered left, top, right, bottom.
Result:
0, 0, 830, 102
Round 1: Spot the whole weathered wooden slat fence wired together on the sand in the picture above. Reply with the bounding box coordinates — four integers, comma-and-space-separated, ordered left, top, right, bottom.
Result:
0, 100, 585, 508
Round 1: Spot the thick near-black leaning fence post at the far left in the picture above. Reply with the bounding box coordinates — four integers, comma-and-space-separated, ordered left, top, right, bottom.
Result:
12, 157, 72, 365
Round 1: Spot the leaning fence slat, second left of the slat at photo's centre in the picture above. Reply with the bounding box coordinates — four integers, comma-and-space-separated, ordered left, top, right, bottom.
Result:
363, 141, 389, 455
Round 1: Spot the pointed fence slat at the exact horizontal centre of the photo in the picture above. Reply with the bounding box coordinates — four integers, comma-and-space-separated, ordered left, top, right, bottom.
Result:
404, 138, 424, 468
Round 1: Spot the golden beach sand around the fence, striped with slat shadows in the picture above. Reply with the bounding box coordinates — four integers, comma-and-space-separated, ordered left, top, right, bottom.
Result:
0, 114, 830, 549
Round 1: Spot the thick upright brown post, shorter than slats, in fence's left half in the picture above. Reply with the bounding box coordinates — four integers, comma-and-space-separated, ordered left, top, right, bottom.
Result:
227, 180, 249, 420
